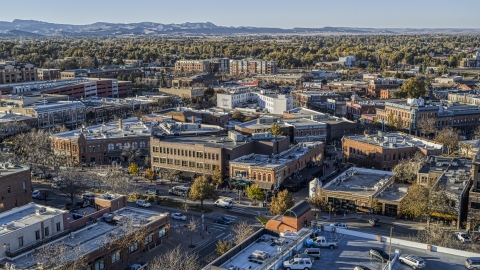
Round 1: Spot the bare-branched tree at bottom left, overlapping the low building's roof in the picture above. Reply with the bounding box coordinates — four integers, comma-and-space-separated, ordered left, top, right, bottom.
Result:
32, 241, 88, 270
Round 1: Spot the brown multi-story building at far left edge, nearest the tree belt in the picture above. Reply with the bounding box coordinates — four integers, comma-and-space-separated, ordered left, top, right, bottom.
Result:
0, 61, 38, 84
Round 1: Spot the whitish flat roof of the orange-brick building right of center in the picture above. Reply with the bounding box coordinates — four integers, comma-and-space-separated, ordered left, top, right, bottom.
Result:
345, 133, 443, 149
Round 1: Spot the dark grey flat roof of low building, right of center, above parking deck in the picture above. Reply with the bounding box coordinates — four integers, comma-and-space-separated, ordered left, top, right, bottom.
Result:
322, 167, 394, 196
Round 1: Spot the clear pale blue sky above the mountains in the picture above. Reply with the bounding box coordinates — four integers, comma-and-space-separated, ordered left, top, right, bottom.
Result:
0, 0, 480, 28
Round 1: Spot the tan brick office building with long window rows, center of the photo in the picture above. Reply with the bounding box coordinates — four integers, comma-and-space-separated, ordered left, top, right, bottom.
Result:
151, 131, 290, 175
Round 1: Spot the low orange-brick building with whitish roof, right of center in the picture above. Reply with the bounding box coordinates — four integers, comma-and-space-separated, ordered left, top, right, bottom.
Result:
342, 131, 443, 171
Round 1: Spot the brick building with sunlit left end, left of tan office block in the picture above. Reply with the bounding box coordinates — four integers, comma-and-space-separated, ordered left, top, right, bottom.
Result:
52, 117, 152, 165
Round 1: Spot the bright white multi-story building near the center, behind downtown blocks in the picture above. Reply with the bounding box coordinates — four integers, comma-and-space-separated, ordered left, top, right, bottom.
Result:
217, 87, 293, 114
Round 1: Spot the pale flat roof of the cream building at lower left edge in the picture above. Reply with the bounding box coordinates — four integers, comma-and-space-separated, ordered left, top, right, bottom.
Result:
0, 202, 67, 235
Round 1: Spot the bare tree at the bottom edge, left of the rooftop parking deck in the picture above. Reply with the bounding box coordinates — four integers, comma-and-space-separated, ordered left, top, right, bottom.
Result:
147, 246, 202, 270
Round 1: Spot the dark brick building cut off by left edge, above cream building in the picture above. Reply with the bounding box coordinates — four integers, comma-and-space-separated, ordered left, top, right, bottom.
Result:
0, 163, 32, 212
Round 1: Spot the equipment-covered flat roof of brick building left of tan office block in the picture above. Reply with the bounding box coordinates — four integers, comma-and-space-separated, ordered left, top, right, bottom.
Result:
53, 117, 153, 140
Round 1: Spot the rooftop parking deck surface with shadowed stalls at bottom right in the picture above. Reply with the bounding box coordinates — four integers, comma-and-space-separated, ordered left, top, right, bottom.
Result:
304, 232, 466, 270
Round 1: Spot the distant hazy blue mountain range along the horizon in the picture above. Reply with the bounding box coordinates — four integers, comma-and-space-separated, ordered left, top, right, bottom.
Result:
0, 20, 480, 38
